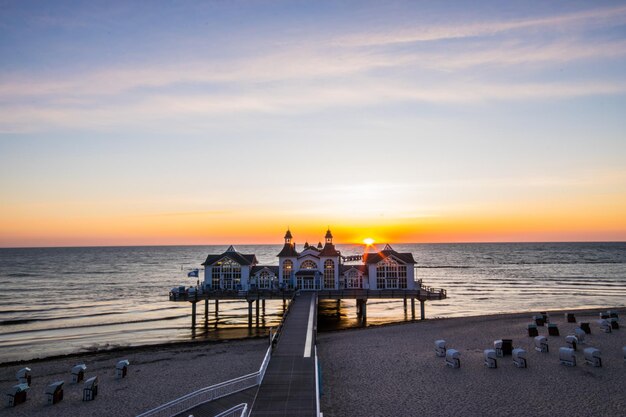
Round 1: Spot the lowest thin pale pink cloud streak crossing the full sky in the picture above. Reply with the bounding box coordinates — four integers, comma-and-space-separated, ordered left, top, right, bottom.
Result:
0, 79, 626, 132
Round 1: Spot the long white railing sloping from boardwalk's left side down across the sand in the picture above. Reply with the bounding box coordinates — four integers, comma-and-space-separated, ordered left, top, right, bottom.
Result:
137, 345, 272, 417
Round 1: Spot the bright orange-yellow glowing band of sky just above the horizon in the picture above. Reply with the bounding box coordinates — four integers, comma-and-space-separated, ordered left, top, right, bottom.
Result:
0, 192, 626, 247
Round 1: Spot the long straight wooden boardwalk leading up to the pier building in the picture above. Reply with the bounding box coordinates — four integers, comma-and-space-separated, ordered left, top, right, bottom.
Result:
250, 291, 317, 417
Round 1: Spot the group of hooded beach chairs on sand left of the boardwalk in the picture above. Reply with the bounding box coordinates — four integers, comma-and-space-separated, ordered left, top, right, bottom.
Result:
7, 359, 130, 407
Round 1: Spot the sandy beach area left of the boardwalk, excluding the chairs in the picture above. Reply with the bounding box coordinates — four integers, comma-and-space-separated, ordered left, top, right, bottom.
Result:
0, 338, 268, 417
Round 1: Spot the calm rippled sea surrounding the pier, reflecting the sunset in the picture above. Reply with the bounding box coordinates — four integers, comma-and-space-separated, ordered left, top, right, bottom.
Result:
0, 243, 626, 363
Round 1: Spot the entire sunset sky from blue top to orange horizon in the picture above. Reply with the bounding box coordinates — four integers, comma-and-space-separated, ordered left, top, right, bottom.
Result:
0, 0, 626, 247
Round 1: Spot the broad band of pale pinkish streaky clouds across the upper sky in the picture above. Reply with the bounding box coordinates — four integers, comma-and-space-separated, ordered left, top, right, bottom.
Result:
0, 2, 626, 132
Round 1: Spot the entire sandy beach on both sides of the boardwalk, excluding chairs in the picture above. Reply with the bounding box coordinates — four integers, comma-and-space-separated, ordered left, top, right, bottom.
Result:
0, 310, 626, 417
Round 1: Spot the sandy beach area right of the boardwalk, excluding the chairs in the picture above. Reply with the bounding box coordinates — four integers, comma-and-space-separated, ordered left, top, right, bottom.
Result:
317, 310, 626, 417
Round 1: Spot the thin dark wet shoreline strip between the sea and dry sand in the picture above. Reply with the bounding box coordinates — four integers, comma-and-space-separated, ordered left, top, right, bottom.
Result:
0, 306, 626, 369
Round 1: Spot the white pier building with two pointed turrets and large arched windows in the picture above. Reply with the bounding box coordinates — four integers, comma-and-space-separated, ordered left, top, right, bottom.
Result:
202, 229, 419, 291
